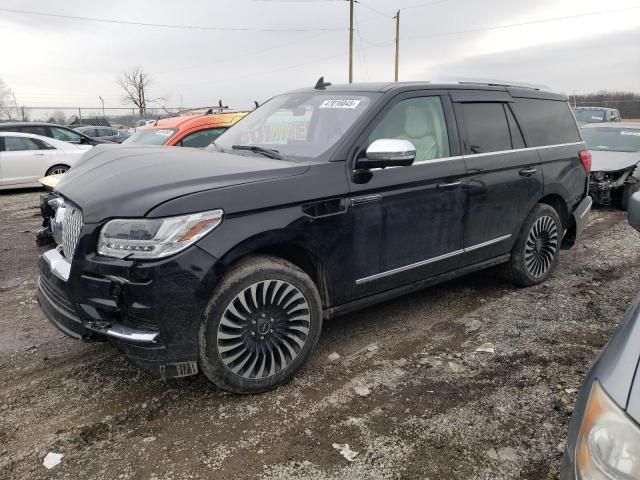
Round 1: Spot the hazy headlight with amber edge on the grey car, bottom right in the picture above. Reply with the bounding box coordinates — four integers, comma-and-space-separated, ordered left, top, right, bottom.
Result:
576, 382, 640, 480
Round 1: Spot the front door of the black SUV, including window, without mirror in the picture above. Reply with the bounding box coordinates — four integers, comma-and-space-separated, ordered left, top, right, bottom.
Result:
350, 91, 466, 297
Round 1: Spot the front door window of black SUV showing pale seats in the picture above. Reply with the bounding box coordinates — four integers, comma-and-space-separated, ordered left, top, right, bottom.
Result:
369, 97, 449, 162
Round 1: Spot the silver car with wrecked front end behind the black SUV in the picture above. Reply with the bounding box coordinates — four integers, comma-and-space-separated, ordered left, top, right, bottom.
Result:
581, 123, 640, 210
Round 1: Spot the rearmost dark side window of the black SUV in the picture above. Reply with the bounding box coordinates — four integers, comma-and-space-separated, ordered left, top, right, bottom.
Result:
513, 98, 580, 147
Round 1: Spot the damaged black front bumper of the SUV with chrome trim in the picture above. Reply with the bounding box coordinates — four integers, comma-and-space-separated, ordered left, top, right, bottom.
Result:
37, 247, 222, 378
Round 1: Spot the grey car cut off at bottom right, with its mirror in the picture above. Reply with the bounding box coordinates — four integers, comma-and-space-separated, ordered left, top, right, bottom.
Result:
560, 189, 640, 480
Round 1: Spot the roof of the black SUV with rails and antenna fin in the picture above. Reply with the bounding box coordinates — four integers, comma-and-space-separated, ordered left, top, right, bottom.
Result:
288, 80, 566, 100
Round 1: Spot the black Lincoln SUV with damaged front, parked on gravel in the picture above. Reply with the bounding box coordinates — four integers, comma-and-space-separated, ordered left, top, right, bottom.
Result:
38, 82, 591, 392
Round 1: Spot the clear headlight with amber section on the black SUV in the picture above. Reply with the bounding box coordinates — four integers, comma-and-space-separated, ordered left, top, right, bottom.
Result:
98, 210, 223, 258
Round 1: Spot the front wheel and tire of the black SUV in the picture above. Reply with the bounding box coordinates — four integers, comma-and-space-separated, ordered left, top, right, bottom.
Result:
199, 255, 322, 393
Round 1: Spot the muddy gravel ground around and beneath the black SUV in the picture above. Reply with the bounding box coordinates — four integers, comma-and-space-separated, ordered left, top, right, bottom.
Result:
0, 191, 640, 479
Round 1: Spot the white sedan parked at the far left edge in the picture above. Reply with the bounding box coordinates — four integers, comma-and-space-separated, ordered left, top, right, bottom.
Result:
0, 132, 92, 190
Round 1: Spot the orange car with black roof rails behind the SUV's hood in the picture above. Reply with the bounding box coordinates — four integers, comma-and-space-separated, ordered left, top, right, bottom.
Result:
123, 112, 247, 148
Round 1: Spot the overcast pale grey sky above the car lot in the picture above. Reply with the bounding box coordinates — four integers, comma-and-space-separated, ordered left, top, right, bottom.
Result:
0, 0, 640, 113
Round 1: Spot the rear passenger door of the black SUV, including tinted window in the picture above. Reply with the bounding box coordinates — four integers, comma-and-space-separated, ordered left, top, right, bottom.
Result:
454, 92, 543, 265
